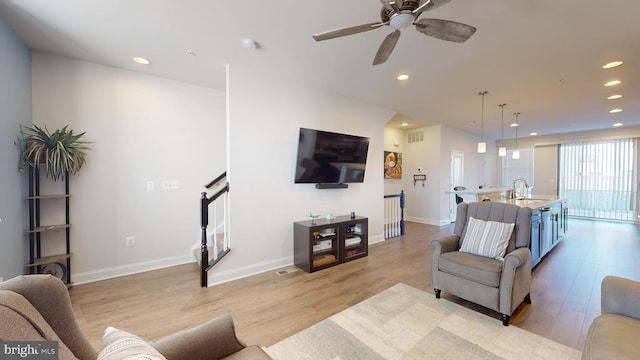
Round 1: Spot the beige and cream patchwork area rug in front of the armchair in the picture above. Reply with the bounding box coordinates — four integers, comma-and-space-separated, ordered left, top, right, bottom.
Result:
265, 283, 581, 360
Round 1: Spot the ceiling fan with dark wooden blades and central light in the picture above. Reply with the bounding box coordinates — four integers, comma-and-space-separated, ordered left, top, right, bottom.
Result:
313, 0, 476, 65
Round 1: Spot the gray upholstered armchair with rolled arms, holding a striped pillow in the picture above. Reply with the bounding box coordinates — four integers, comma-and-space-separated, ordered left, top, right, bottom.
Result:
431, 202, 531, 326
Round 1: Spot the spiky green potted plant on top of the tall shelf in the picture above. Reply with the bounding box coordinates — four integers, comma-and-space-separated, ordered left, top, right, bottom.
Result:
20, 125, 89, 180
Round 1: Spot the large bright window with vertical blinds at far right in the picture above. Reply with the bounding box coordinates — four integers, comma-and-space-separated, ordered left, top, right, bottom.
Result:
558, 139, 637, 221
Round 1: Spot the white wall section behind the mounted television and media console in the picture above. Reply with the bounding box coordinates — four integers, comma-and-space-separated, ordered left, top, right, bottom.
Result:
209, 66, 395, 284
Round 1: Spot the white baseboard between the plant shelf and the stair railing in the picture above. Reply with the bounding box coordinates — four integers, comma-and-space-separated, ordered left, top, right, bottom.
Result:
71, 254, 195, 285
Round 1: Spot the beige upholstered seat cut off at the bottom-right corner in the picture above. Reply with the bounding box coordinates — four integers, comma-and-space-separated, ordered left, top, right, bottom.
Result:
582, 276, 640, 360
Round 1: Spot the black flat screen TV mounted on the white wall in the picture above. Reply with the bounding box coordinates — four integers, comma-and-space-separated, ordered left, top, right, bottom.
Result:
295, 128, 369, 184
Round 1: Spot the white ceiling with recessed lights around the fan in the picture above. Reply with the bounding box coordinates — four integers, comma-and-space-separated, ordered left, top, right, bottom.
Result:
0, 0, 640, 138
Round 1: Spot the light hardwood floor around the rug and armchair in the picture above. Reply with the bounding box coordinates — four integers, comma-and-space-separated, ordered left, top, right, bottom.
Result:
70, 219, 640, 349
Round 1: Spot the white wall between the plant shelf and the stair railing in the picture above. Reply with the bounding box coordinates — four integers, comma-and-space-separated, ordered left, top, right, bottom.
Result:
32, 53, 226, 283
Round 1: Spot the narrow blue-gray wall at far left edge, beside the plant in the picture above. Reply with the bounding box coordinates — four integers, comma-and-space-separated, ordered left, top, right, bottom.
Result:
0, 18, 31, 279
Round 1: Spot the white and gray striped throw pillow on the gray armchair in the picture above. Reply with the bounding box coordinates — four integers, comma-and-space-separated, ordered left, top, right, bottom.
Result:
460, 217, 515, 261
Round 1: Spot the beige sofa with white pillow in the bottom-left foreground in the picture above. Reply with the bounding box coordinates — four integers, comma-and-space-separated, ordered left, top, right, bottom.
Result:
0, 275, 270, 360
